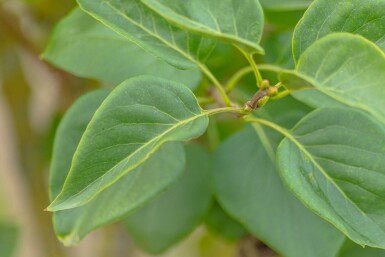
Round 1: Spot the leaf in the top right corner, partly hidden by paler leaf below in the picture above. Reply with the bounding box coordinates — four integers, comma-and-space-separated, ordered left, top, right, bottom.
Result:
293, 0, 385, 60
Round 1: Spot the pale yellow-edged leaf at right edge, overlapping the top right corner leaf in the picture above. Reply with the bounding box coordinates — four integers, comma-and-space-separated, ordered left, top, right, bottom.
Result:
281, 33, 385, 123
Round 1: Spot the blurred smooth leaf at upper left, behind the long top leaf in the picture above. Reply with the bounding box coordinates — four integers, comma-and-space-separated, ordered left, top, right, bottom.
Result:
42, 8, 201, 88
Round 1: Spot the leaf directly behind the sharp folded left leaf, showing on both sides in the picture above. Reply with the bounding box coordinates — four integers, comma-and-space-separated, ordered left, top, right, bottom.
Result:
47, 90, 185, 244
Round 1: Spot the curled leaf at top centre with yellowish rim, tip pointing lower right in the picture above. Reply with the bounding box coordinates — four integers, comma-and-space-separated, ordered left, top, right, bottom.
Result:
142, 0, 264, 54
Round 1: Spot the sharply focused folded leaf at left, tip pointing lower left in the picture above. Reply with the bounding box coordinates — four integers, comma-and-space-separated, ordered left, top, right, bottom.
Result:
48, 77, 208, 211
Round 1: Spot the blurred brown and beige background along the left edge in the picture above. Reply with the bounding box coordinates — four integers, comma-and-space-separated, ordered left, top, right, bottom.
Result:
0, 0, 109, 257
